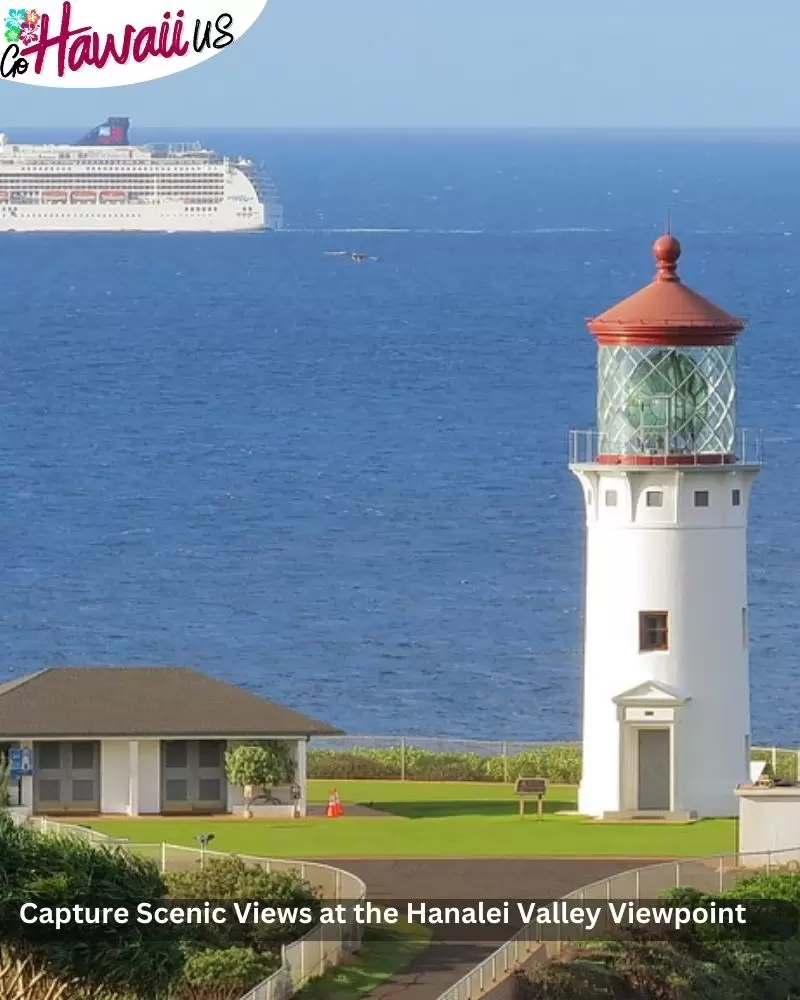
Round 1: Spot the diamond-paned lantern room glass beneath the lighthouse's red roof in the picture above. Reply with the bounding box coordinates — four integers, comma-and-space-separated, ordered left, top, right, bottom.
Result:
597, 345, 736, 456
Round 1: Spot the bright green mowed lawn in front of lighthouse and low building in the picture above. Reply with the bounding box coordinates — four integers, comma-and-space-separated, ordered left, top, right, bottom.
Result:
87, 781, 736, 858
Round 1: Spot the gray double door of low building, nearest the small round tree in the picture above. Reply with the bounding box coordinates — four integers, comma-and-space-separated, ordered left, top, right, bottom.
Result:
161, 740, 227, 812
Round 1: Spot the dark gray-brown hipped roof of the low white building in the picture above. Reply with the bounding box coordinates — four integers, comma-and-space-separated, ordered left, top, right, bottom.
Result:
0, 667, 341, 739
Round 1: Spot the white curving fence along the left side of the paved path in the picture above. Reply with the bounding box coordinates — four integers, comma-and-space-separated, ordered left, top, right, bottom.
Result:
21, 817, 367, 1000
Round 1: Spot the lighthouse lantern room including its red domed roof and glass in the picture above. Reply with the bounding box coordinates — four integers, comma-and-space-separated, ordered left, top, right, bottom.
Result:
588, 234, 744, 465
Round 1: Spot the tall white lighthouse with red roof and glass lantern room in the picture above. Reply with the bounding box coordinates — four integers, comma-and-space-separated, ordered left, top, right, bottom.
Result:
570, 235, 760, 820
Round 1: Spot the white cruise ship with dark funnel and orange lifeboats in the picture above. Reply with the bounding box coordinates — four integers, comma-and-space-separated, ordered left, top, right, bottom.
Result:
0, 118, 281, 233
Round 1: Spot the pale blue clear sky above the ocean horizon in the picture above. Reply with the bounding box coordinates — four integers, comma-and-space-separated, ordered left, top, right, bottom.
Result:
0, 0, 800, 131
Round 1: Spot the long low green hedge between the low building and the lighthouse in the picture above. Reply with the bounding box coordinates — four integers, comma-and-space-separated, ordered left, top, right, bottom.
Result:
308, 743, 581, 785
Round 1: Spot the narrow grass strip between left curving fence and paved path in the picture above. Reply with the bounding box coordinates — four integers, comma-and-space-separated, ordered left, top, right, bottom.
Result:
298, 924, 431, 1000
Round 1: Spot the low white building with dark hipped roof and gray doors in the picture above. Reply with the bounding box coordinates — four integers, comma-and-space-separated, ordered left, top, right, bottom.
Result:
0, 667, 340, 816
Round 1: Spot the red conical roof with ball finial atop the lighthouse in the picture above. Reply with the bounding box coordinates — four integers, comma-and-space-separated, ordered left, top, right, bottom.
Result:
588, 234, 745, 347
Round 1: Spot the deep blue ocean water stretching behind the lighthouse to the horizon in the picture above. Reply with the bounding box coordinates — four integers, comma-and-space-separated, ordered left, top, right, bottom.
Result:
0, 129, 800, 744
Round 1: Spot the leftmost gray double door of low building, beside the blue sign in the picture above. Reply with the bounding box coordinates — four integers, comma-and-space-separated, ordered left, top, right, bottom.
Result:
33, 740, 100, 813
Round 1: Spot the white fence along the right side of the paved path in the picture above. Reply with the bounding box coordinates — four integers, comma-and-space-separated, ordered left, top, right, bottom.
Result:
437, 848, 800, 1000
